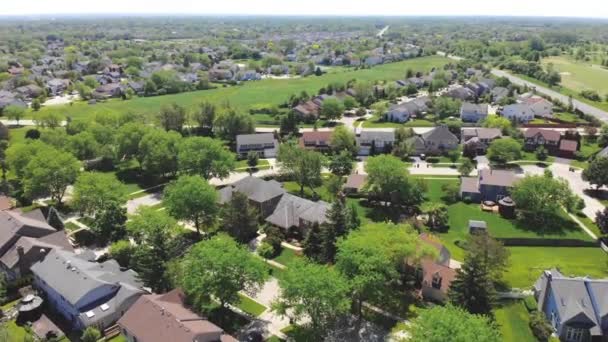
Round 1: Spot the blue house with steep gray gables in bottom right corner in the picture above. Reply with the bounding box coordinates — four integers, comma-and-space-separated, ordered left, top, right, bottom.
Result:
534, 269, 608, 341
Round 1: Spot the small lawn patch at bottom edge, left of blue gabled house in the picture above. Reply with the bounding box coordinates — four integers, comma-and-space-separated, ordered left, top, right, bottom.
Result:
494, 300, 536, 342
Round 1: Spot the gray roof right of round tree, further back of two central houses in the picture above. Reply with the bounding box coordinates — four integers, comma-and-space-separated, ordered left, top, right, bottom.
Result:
220, 176, 285, 203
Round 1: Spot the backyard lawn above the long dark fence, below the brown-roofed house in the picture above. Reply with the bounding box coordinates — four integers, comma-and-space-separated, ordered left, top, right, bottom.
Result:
438, 202, 591, 260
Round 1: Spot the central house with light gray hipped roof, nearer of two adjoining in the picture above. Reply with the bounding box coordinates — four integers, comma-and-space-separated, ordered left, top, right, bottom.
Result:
266, 193, 330, 235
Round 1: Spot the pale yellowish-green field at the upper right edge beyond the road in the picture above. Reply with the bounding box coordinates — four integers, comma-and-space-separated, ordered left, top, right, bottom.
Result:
542, 56, 608, 96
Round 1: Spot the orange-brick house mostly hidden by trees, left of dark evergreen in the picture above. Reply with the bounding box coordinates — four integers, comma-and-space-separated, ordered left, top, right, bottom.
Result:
416, 233, 456, 302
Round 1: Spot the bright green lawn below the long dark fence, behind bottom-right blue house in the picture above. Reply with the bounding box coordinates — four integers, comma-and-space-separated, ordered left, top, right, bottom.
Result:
504, 247, 608, 288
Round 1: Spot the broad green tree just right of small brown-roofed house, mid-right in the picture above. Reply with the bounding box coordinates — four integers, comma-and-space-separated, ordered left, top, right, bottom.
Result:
365, 155, 424, 206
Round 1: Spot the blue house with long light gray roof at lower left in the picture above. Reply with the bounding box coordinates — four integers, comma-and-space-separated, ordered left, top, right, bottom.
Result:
31, 249, 145, 330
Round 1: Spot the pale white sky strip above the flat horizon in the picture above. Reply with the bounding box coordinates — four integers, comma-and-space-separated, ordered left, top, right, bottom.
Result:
0, 0, 608, 18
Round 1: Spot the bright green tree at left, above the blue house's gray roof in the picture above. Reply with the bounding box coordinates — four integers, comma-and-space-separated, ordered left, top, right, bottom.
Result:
72, 172, 126, 215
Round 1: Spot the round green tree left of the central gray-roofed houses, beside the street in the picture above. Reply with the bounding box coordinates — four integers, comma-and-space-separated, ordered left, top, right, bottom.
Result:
163, 176, 219, 234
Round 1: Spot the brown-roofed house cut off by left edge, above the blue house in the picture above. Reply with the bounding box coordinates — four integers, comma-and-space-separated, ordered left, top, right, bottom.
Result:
0, 209, 73, 281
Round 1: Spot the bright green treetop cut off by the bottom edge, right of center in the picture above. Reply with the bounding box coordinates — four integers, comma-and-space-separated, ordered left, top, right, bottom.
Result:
408, 305, 502, 342
